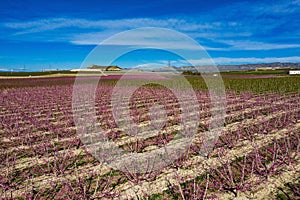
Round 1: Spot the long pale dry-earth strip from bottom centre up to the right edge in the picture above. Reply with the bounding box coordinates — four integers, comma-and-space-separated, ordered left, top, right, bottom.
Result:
112, 123, 300, 199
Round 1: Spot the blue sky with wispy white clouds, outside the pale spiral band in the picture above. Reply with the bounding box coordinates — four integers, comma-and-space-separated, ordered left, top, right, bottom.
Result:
0, 0, 300, 70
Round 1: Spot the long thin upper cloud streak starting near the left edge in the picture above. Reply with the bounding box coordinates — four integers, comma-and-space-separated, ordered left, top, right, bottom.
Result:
3, 18, 217, 34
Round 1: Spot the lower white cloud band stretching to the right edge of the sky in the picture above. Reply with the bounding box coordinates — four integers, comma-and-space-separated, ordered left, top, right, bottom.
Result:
70, 31, 300, 51
